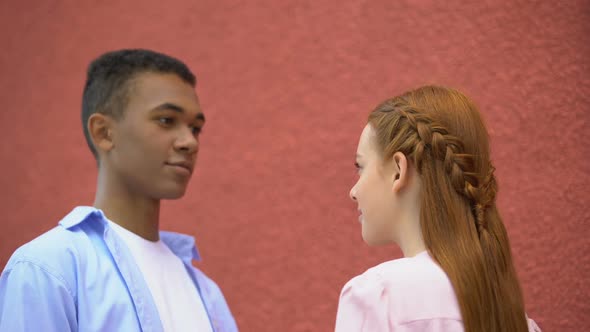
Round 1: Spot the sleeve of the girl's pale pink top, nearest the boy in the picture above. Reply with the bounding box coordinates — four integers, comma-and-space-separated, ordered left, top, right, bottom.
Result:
335, 275, 390, 332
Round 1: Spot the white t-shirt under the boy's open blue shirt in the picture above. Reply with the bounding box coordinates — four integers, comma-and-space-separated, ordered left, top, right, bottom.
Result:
109, 220, 213, 332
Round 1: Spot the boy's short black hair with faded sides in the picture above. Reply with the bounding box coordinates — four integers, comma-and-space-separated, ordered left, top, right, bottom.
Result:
82, 49, 196, 159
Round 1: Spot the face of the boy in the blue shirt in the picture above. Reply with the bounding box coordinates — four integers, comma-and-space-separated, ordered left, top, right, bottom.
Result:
103, 73, 205, 199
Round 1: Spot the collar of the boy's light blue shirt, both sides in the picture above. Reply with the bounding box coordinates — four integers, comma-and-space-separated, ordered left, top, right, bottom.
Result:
59, 206, 201, 264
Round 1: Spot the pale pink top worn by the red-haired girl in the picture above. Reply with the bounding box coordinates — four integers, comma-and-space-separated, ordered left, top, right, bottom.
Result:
336, 251, 541, 332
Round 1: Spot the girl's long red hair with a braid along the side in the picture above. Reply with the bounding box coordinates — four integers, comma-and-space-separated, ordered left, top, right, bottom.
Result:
369, 86, 528, 332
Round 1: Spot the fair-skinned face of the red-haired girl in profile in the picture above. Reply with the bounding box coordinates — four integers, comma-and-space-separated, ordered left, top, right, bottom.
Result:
350, 124, 398, 245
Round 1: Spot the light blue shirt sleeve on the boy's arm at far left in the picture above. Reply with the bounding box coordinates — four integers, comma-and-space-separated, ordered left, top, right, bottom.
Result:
0, 261, 77, 332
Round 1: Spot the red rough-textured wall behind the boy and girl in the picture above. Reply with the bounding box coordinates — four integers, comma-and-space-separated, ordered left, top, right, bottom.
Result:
0, 0, 590, 331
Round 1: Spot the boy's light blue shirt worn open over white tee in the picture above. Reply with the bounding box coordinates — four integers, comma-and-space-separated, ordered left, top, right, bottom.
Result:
0, 207, 238, 332
